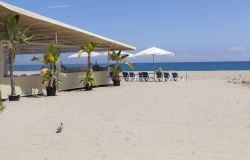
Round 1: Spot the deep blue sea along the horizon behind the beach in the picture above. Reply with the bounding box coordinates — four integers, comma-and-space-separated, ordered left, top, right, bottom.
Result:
15, 61, 250, 71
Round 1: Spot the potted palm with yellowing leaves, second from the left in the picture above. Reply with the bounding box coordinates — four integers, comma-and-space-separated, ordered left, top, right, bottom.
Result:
32, 42, 60, 96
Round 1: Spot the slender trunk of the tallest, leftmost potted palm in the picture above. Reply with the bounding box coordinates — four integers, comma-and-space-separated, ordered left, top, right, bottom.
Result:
9, 49, 16, 96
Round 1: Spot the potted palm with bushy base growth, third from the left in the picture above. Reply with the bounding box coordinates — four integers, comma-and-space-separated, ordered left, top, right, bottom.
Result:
78, 42, 98, 91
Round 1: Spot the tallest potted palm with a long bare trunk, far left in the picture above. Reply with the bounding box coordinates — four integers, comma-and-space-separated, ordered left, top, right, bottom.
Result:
3, 15, 33, 101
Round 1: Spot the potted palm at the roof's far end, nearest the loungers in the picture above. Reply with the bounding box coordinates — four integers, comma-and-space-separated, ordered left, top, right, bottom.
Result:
109, 51, 134, 86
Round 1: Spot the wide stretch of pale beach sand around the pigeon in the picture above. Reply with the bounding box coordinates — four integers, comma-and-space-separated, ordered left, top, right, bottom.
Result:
0, 71, 250, 160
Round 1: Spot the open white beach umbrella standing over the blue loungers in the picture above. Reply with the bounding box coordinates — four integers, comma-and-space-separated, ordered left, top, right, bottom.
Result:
134, 47, 174, 79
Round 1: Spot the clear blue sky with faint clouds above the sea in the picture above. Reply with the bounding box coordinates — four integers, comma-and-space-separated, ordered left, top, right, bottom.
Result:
1, 0, 250, 61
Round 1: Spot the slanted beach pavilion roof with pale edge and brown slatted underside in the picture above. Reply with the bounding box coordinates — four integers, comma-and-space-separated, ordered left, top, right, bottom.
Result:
0, 1, 135, 53
